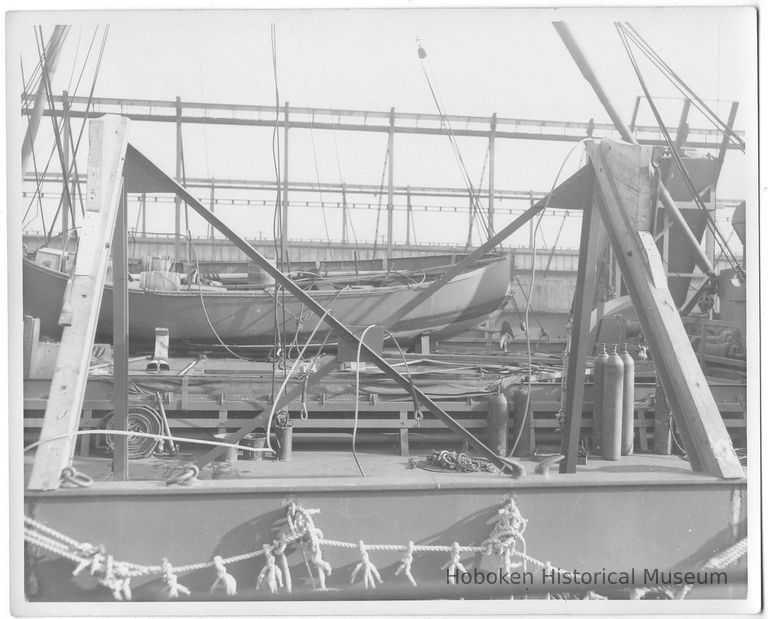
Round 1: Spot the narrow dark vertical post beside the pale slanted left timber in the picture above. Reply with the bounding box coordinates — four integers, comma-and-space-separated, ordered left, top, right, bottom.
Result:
112, 183, 128, 481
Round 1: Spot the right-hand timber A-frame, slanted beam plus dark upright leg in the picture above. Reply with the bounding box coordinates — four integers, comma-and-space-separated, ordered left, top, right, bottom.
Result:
561, 139, 744, 479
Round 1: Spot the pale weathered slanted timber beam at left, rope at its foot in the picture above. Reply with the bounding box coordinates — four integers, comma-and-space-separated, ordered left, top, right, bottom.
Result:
29, 116, 129, 490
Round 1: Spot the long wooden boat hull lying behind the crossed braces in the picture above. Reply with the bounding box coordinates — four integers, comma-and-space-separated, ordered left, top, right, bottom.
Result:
24, 256, 512, 345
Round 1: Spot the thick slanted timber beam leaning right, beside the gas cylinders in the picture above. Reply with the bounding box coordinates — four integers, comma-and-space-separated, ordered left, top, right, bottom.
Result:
587, 140, 744, 479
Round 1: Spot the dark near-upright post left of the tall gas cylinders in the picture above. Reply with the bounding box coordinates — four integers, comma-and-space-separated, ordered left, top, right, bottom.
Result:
560, 165, 600, 473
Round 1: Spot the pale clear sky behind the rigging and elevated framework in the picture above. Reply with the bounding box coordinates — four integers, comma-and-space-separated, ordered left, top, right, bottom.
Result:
7, 8, 757, 252
